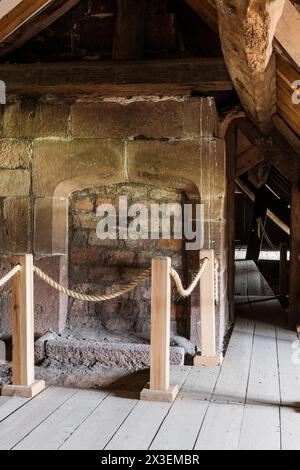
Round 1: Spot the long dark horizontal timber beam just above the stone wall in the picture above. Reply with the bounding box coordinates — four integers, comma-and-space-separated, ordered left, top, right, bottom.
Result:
0, 59, 232, 96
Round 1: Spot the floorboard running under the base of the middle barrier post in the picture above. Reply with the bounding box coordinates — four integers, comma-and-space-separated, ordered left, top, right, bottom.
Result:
106, 367, 190, 450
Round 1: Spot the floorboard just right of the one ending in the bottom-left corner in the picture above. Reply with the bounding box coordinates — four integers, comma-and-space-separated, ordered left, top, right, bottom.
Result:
15, 390, 108, 450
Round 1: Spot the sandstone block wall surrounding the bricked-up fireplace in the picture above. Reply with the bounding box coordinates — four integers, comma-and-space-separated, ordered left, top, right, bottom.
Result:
0, 96, 227, 352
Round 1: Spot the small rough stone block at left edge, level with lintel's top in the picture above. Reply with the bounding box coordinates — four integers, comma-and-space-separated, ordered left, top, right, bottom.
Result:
0, 139, 31, 170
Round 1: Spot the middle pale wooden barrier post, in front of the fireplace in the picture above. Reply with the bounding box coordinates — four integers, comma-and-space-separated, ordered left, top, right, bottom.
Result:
141, 258, 179, 402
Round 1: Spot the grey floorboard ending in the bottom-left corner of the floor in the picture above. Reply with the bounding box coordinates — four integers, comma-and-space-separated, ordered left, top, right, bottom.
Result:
0, 387, 75, 450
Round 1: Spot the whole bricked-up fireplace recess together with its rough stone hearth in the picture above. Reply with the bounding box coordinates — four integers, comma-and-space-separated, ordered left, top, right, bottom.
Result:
32, 183, 199, 387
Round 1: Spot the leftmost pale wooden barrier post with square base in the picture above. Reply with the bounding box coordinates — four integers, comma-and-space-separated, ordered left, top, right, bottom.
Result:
2, 255, 45, 398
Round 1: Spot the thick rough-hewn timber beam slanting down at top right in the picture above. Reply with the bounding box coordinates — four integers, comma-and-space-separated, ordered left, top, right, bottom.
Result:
216, 0, 285, 134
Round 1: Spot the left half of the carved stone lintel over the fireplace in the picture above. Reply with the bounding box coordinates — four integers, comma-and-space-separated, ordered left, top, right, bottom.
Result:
33, 139, 126, 197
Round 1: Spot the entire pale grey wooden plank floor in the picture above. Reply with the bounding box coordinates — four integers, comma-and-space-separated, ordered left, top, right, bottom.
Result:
0, 319, 300, 450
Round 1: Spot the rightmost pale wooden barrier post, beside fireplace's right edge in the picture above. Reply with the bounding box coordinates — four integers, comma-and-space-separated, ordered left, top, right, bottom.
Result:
194, 250, 223, 366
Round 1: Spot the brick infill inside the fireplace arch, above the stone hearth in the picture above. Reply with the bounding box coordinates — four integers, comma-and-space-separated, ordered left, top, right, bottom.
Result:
67, 184, 188, 343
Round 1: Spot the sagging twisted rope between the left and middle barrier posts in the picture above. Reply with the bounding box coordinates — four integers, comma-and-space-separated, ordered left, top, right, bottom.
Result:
33, 266, 151, 302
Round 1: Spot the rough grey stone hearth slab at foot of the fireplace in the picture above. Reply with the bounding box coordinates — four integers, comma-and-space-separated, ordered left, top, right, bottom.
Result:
29, 329, 186, 391
